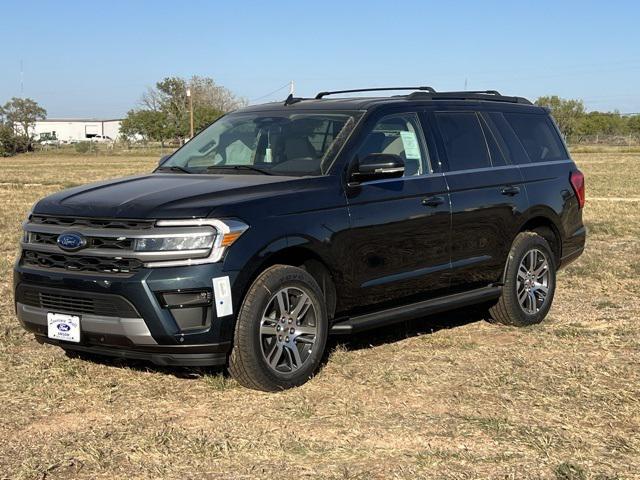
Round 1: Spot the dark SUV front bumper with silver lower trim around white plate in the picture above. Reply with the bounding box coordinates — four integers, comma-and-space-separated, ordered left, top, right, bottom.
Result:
14, 263, 238, 366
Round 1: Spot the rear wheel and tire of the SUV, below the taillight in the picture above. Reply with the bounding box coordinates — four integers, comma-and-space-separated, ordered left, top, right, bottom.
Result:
489, 232, 556, 327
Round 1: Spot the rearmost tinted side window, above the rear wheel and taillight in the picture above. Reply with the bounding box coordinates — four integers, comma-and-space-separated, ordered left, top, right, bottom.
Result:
504, 113, 568, 162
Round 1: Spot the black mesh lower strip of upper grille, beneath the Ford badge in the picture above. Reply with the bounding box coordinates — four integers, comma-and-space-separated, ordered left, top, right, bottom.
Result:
22, 250, 143, 274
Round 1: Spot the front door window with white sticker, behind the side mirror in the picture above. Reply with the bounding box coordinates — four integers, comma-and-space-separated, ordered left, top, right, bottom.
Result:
358, 113, 426, 177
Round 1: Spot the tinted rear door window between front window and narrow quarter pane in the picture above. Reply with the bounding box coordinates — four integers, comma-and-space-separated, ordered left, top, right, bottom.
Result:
436, 112, 491, 171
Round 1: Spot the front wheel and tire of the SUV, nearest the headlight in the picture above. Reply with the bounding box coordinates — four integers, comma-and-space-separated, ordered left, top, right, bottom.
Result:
229, 265, 329, 391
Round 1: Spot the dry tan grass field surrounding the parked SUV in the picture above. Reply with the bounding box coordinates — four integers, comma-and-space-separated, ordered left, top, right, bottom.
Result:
0, 149, 640, 480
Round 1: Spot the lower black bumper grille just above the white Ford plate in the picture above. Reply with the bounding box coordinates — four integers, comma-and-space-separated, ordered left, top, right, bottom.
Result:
16, 284, 140, 318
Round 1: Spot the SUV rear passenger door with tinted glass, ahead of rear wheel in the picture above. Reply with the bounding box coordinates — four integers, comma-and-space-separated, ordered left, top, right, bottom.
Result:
429, 109, 528, 292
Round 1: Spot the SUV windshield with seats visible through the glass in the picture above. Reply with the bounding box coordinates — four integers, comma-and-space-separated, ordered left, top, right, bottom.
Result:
160, 112, 360, 176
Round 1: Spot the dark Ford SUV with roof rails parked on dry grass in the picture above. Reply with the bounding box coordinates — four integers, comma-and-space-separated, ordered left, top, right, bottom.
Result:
14, 87, 585, 390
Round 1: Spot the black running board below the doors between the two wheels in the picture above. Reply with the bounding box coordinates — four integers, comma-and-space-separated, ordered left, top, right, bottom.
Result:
330, 286, 502, 334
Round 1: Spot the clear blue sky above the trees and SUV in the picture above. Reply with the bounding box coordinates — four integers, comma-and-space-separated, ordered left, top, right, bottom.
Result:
0, 0, 640, 118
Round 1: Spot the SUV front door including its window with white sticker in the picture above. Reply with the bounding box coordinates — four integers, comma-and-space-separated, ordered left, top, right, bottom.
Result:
345, 112, 451, 314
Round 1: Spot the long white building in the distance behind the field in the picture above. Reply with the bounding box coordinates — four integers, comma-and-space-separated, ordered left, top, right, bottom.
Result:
27, 118, 122, 142
